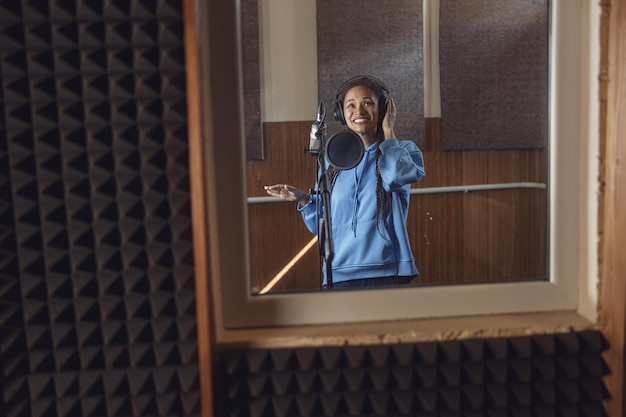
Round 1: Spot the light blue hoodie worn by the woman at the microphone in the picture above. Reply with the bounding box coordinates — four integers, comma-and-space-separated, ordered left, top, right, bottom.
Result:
298, 139, 425, 284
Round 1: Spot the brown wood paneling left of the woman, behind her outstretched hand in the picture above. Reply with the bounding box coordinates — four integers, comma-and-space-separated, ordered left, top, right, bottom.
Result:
247, 121, 326, 291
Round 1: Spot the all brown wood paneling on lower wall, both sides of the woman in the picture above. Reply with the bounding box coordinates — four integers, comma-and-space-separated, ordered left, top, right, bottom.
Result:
247, 120, 546, 291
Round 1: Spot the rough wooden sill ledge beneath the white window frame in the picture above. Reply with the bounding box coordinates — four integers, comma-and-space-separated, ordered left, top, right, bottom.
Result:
216, 311, 597, 350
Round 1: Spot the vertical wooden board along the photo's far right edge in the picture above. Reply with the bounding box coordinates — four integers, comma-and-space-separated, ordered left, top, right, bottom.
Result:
599, 0, 626, 417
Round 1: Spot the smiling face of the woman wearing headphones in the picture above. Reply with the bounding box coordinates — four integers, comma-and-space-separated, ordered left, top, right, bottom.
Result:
343, 86, 378, 135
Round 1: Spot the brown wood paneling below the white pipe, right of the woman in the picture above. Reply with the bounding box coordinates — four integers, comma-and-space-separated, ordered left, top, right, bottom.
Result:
407, 189, 546, 285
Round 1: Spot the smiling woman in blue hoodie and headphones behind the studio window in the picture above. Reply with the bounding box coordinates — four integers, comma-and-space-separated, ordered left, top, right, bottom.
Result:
265, 76, 425, 288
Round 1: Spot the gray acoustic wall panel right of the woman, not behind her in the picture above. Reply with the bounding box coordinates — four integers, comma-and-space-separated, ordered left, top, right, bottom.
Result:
439, 0, 550, 150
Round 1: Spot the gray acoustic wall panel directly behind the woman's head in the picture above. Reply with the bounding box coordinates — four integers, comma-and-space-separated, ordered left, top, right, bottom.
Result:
311, 0, 424, 146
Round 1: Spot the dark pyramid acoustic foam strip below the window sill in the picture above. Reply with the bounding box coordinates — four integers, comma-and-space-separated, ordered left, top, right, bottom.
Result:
217, 331, 607, 417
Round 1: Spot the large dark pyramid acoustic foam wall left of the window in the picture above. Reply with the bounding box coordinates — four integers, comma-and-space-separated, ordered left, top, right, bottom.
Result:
0, 0, 200, 417
